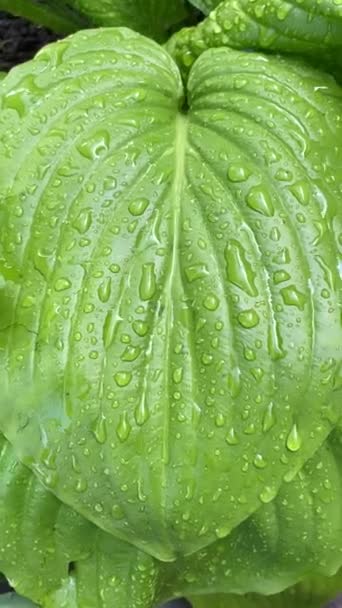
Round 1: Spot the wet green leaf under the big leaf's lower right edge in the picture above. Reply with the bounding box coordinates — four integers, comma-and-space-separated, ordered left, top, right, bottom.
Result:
162, 434, 342, 596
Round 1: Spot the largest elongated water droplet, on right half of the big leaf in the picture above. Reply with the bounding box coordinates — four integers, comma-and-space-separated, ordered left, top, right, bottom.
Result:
225, 240, 258, 296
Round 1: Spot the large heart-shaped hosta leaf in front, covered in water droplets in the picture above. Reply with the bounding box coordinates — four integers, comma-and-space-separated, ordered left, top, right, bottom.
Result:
0, 29, 342, 560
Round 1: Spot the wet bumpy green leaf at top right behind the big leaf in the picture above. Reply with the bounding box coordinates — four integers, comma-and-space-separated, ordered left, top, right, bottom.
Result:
167, 0, 342, 77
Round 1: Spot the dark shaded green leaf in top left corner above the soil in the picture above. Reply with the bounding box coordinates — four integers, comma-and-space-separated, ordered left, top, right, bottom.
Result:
0, 0, 89, 34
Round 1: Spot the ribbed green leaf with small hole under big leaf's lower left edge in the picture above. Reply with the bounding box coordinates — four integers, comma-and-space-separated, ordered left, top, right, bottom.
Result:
0, 438, 158, 608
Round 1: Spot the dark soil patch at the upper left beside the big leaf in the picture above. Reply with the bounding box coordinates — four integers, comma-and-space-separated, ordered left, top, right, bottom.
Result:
0, 11, 57, 72
